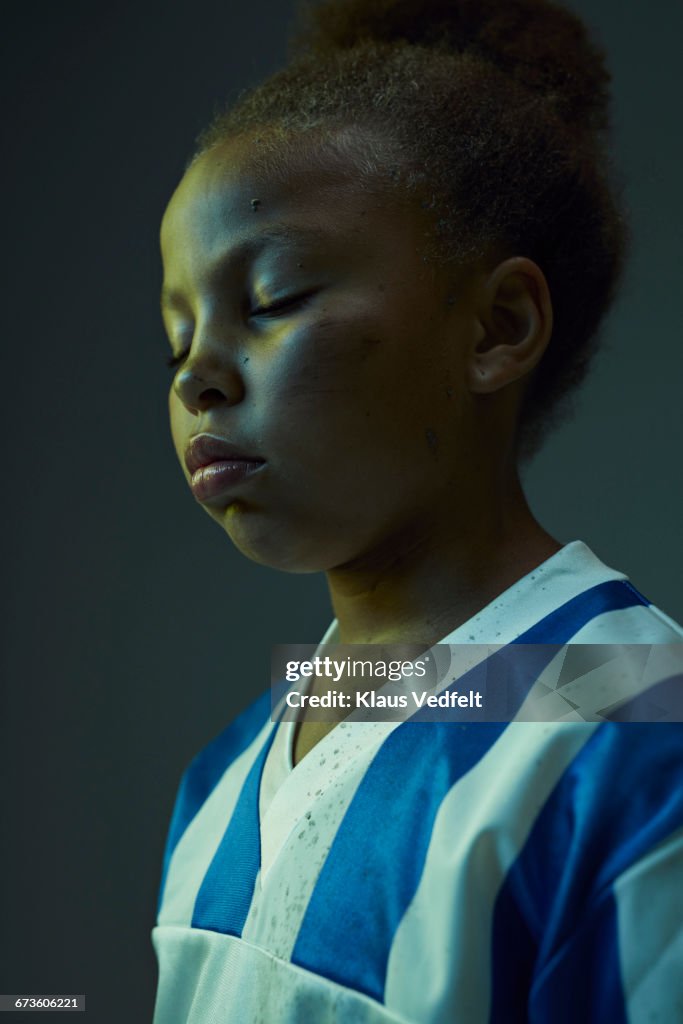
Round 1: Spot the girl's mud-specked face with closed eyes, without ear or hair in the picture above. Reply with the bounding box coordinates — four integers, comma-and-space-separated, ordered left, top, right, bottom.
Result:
161, 132, 485, 572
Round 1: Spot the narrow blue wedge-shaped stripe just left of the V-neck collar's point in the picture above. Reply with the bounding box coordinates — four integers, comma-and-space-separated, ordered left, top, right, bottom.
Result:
191, 725, 278, 935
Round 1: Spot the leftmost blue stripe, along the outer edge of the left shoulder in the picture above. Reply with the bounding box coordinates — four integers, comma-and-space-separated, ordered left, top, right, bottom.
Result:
158, 690, 270, 909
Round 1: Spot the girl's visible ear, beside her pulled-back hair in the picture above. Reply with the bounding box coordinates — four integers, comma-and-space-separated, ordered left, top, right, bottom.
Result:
467, 256, 553, 394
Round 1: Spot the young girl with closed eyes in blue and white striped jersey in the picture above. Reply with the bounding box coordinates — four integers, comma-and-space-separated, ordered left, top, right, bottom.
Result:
153, 0, 683, 1024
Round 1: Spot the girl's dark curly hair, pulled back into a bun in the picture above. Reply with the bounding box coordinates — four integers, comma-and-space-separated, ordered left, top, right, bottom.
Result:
193, 0, 628, 461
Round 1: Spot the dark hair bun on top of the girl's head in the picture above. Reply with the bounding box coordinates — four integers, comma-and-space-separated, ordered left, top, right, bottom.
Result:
294, 0, 610, 130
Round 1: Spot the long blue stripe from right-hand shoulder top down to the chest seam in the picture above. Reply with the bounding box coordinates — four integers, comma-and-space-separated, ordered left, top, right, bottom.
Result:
292, 581, 644, 1000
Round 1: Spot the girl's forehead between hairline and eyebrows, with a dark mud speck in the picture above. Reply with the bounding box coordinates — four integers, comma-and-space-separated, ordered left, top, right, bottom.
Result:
161, 137, 425, 280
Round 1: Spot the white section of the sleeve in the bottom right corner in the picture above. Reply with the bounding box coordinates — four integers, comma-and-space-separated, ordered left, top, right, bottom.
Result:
613, 829, 683, 1024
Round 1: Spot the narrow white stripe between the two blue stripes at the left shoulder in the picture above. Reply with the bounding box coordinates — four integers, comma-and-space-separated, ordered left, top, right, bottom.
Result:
159, 718, 272, 925
